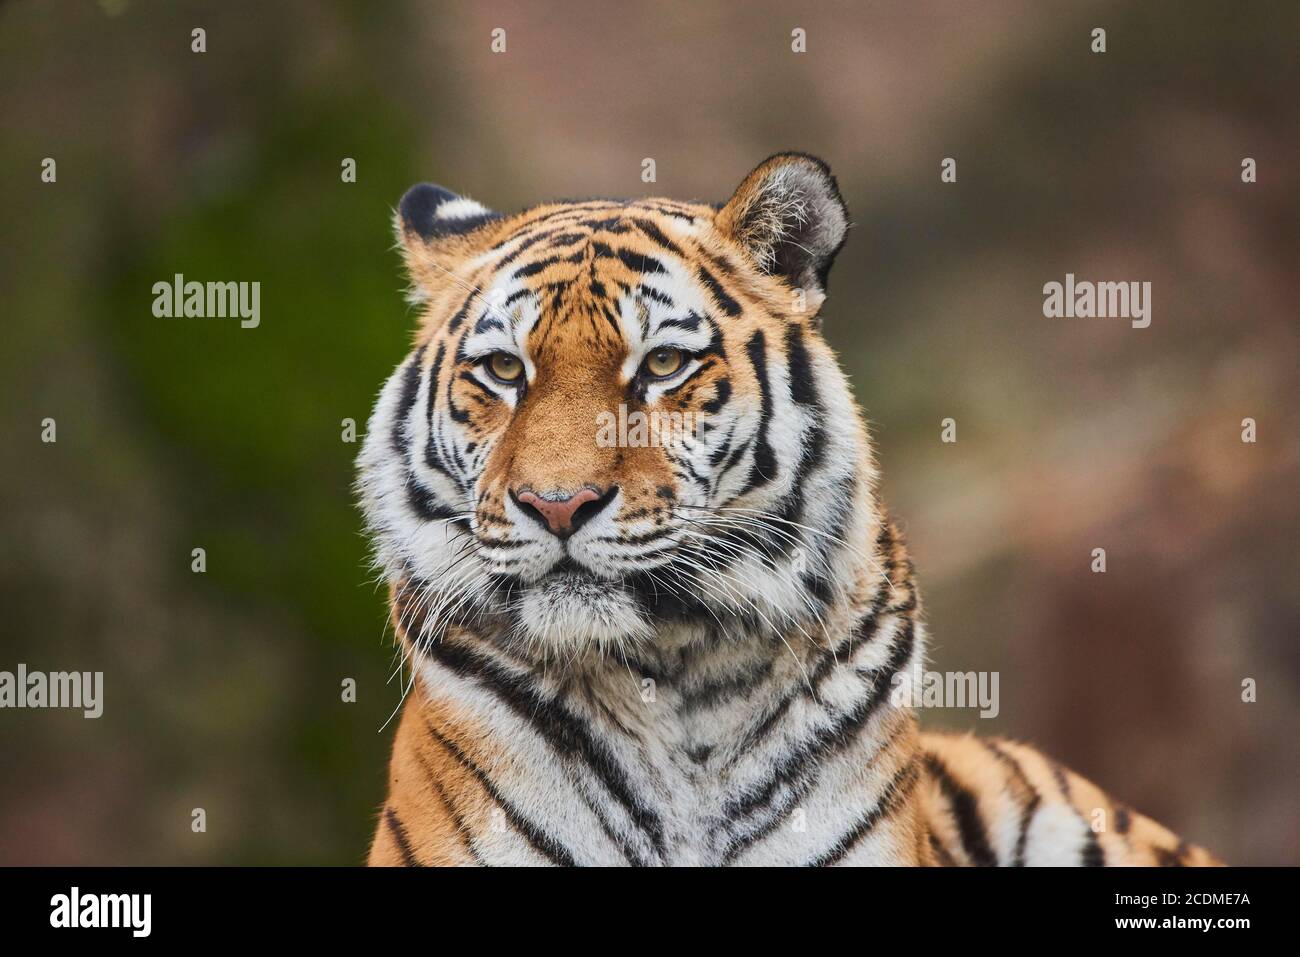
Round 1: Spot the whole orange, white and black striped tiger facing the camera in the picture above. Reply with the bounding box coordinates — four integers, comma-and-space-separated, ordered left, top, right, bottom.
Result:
358, 153, 1217, 866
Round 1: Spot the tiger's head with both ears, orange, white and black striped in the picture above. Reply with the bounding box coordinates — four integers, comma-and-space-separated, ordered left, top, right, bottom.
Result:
359, 153, 874, 655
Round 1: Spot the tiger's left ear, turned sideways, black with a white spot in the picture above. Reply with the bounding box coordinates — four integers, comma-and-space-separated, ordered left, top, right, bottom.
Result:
394, 183, 502, 286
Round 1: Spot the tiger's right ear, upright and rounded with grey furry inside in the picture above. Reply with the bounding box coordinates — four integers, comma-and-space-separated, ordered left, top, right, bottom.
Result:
714, 153, 849, 293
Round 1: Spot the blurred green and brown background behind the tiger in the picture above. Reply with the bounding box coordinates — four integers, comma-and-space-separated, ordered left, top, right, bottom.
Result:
0, 0, 1300, 865
